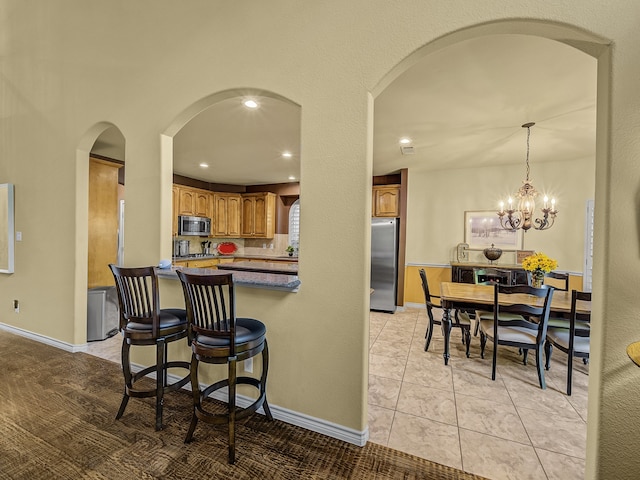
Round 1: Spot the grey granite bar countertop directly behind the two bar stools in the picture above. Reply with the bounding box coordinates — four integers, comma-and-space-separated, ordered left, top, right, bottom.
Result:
156, 266, 301, 292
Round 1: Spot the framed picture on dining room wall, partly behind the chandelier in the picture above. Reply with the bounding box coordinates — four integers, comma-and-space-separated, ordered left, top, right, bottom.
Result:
464, 210, 522, 250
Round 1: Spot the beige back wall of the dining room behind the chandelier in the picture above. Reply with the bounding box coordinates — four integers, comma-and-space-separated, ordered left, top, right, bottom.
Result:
406, 156, 595, 273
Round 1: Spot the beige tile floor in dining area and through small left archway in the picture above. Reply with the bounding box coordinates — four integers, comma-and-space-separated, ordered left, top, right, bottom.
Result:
88, 308, 588, 480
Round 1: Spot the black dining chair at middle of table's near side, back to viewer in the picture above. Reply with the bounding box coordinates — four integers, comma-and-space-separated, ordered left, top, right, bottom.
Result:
480, 284, 554, 389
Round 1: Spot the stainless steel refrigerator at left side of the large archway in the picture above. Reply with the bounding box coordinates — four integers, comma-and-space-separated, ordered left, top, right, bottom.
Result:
370, 218, 398, 313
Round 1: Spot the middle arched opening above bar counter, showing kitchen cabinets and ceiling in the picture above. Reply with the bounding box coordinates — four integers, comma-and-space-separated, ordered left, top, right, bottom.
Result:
162, 89, 301, 261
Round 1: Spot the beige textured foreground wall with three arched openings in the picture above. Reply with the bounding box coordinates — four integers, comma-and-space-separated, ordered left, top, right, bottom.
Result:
0, 0, 640, 479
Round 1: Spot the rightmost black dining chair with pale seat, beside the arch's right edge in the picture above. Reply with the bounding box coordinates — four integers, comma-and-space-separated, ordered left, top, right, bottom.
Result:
544, 290, 591, 395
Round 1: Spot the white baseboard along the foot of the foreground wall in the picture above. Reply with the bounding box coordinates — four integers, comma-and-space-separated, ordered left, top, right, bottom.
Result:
0, 323, 369, 447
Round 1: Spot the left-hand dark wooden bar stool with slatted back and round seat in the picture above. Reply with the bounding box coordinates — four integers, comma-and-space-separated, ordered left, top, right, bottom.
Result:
109, 264, 190, 430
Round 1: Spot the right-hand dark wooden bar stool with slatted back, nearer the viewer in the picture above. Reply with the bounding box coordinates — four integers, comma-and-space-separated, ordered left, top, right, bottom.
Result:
177, 270, 273, 464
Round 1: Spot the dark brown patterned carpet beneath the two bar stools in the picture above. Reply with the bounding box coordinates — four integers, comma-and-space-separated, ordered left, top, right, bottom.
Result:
0, 331, 481, 480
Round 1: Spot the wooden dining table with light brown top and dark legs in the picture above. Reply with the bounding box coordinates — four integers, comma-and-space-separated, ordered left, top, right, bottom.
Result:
440, 282, 591, 365
